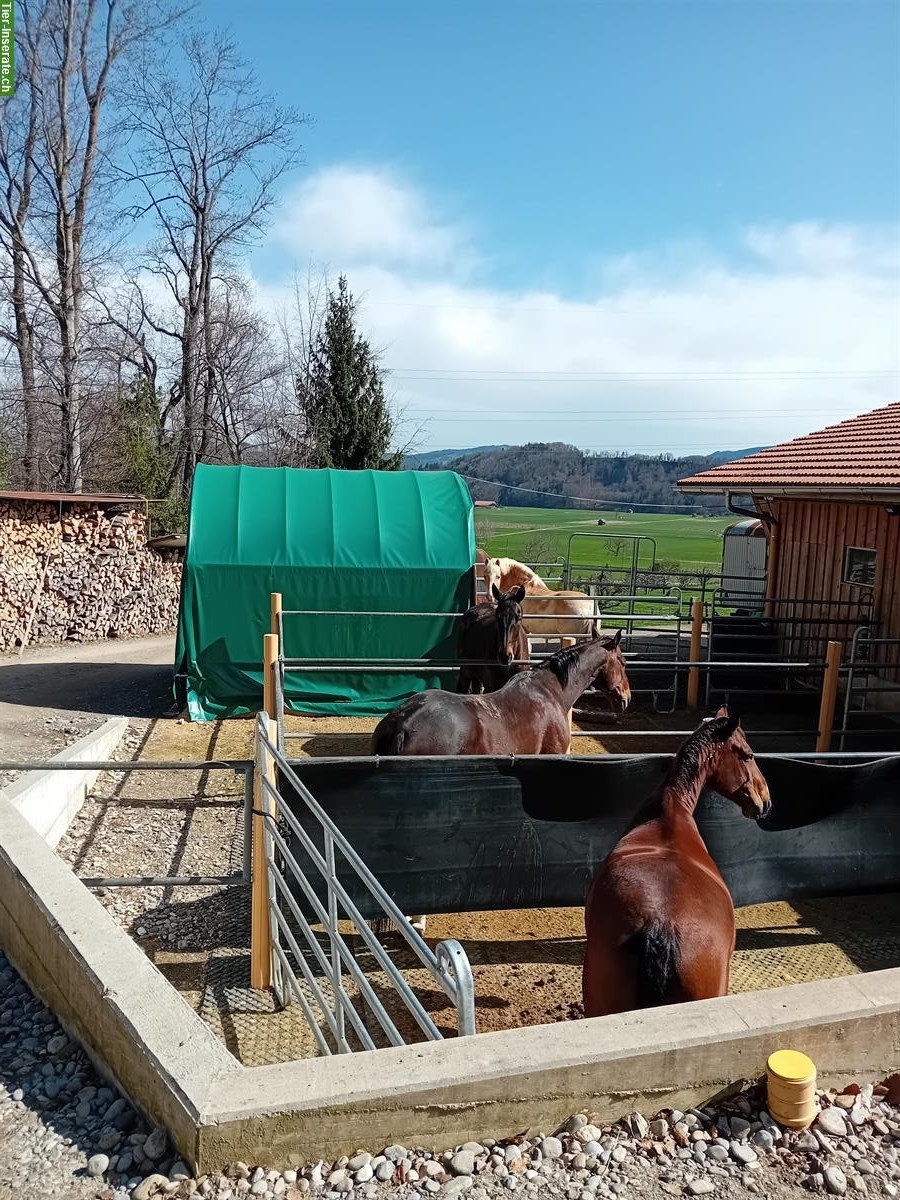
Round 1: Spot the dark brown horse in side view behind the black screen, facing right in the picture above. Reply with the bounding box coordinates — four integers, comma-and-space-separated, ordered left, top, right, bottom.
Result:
372, 630, 631, 755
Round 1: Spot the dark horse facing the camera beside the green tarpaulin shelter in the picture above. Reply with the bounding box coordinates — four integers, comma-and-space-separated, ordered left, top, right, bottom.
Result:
456, 584, 529, 695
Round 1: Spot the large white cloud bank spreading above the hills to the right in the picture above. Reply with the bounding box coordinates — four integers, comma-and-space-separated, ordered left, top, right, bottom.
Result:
257, 168, 900, 454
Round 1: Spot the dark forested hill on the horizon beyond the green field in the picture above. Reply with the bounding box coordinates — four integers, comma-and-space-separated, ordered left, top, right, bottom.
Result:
426, 442, 761, 512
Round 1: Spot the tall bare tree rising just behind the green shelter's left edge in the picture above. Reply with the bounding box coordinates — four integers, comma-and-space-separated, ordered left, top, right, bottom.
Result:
128, 34, 302, 491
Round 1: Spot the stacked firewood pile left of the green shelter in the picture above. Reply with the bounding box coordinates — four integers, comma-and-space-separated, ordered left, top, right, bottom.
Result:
0, 499, 181, 652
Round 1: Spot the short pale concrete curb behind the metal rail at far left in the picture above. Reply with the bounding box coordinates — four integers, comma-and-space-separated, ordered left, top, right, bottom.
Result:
0, 716, 128, 850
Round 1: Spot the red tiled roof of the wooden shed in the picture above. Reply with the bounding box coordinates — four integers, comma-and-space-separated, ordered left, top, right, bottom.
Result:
678, 403, 900, 494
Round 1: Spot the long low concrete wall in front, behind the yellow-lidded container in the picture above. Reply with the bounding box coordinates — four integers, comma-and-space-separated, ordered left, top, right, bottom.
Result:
199, 970, 900, 1169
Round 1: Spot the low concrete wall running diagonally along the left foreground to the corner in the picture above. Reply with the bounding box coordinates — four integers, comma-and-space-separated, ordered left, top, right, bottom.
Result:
0, 798, 240, 1160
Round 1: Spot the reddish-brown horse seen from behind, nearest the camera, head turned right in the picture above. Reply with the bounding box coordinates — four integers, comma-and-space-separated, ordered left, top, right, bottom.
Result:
582, 708, 772, 1016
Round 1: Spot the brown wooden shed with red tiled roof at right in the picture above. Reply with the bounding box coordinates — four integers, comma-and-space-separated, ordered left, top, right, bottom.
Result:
678, 403, 900, 686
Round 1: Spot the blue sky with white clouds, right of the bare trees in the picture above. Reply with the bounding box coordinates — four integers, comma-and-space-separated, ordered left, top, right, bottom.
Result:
200, 0, 900, 452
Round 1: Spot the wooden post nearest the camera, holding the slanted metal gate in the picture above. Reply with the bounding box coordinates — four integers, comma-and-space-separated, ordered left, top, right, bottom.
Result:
250, 634, 278, 988
